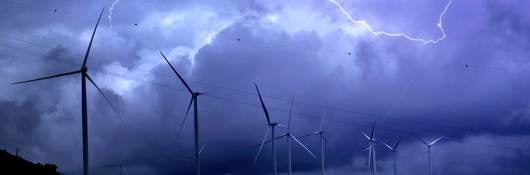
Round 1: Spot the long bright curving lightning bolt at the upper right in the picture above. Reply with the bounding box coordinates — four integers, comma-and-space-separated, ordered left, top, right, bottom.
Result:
328, 0, 453, 45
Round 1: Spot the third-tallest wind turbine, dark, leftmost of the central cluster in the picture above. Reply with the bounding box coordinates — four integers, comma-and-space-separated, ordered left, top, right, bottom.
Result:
252, 84, 278, 175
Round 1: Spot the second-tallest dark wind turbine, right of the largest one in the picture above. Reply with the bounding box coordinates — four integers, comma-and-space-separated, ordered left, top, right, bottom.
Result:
160, 51, 203, 175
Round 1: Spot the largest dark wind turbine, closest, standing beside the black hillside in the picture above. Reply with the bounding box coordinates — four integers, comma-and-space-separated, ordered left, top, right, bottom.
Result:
12, 9, 117, 175
